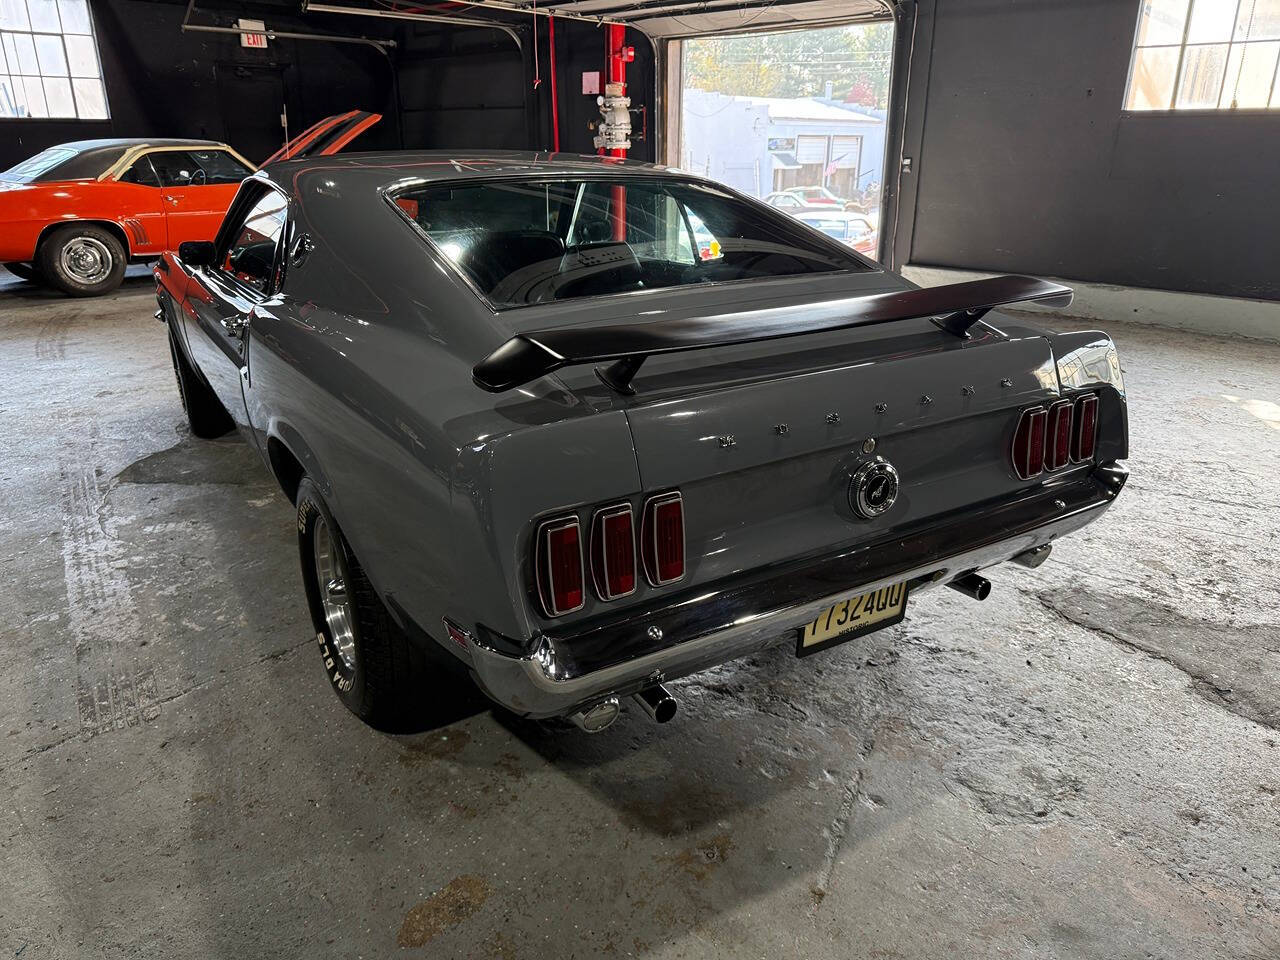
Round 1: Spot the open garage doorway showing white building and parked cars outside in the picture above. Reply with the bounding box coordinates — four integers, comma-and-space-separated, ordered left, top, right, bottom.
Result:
667, 20, 893, 257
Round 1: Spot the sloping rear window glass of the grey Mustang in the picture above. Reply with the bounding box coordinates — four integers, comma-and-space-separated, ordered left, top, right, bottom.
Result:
393, 177, 872, 308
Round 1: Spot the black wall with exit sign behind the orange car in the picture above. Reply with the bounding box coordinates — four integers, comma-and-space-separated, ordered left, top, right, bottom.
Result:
0, 0, 397, 169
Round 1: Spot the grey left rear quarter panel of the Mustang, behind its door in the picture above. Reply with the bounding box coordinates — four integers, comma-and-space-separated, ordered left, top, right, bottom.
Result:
246, 166, 596, 655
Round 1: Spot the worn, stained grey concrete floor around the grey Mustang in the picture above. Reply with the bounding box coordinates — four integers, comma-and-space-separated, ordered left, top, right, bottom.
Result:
0, 276, 1280, 960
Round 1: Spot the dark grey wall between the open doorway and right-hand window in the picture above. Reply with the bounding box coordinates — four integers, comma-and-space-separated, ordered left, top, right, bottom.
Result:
897, 0, 1280, 300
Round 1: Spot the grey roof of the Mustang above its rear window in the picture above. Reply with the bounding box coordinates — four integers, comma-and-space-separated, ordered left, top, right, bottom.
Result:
254, 150, 686, 186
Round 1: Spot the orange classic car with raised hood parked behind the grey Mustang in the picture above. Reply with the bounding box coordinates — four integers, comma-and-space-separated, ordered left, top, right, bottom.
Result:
0, 110, 381, 297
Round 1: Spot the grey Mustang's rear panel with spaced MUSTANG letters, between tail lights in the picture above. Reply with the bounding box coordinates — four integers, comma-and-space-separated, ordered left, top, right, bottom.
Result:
627, 332, 1057, 593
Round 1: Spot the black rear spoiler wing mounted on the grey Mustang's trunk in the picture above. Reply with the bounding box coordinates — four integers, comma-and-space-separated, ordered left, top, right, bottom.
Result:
471, 276, 1073, 394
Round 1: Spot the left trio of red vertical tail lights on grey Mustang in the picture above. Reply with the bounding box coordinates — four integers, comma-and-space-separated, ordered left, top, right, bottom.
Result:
534, 490, 685, 617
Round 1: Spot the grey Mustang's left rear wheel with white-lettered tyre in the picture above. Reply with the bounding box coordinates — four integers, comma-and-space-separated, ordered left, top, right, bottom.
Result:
297, 477, 436, 732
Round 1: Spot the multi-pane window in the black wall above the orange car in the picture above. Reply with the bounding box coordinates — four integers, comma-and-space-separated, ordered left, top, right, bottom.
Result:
0, 0, 108, 120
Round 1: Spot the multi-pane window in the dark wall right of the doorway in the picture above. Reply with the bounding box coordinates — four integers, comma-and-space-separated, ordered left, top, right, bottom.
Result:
1125, 0, 1280, 110
